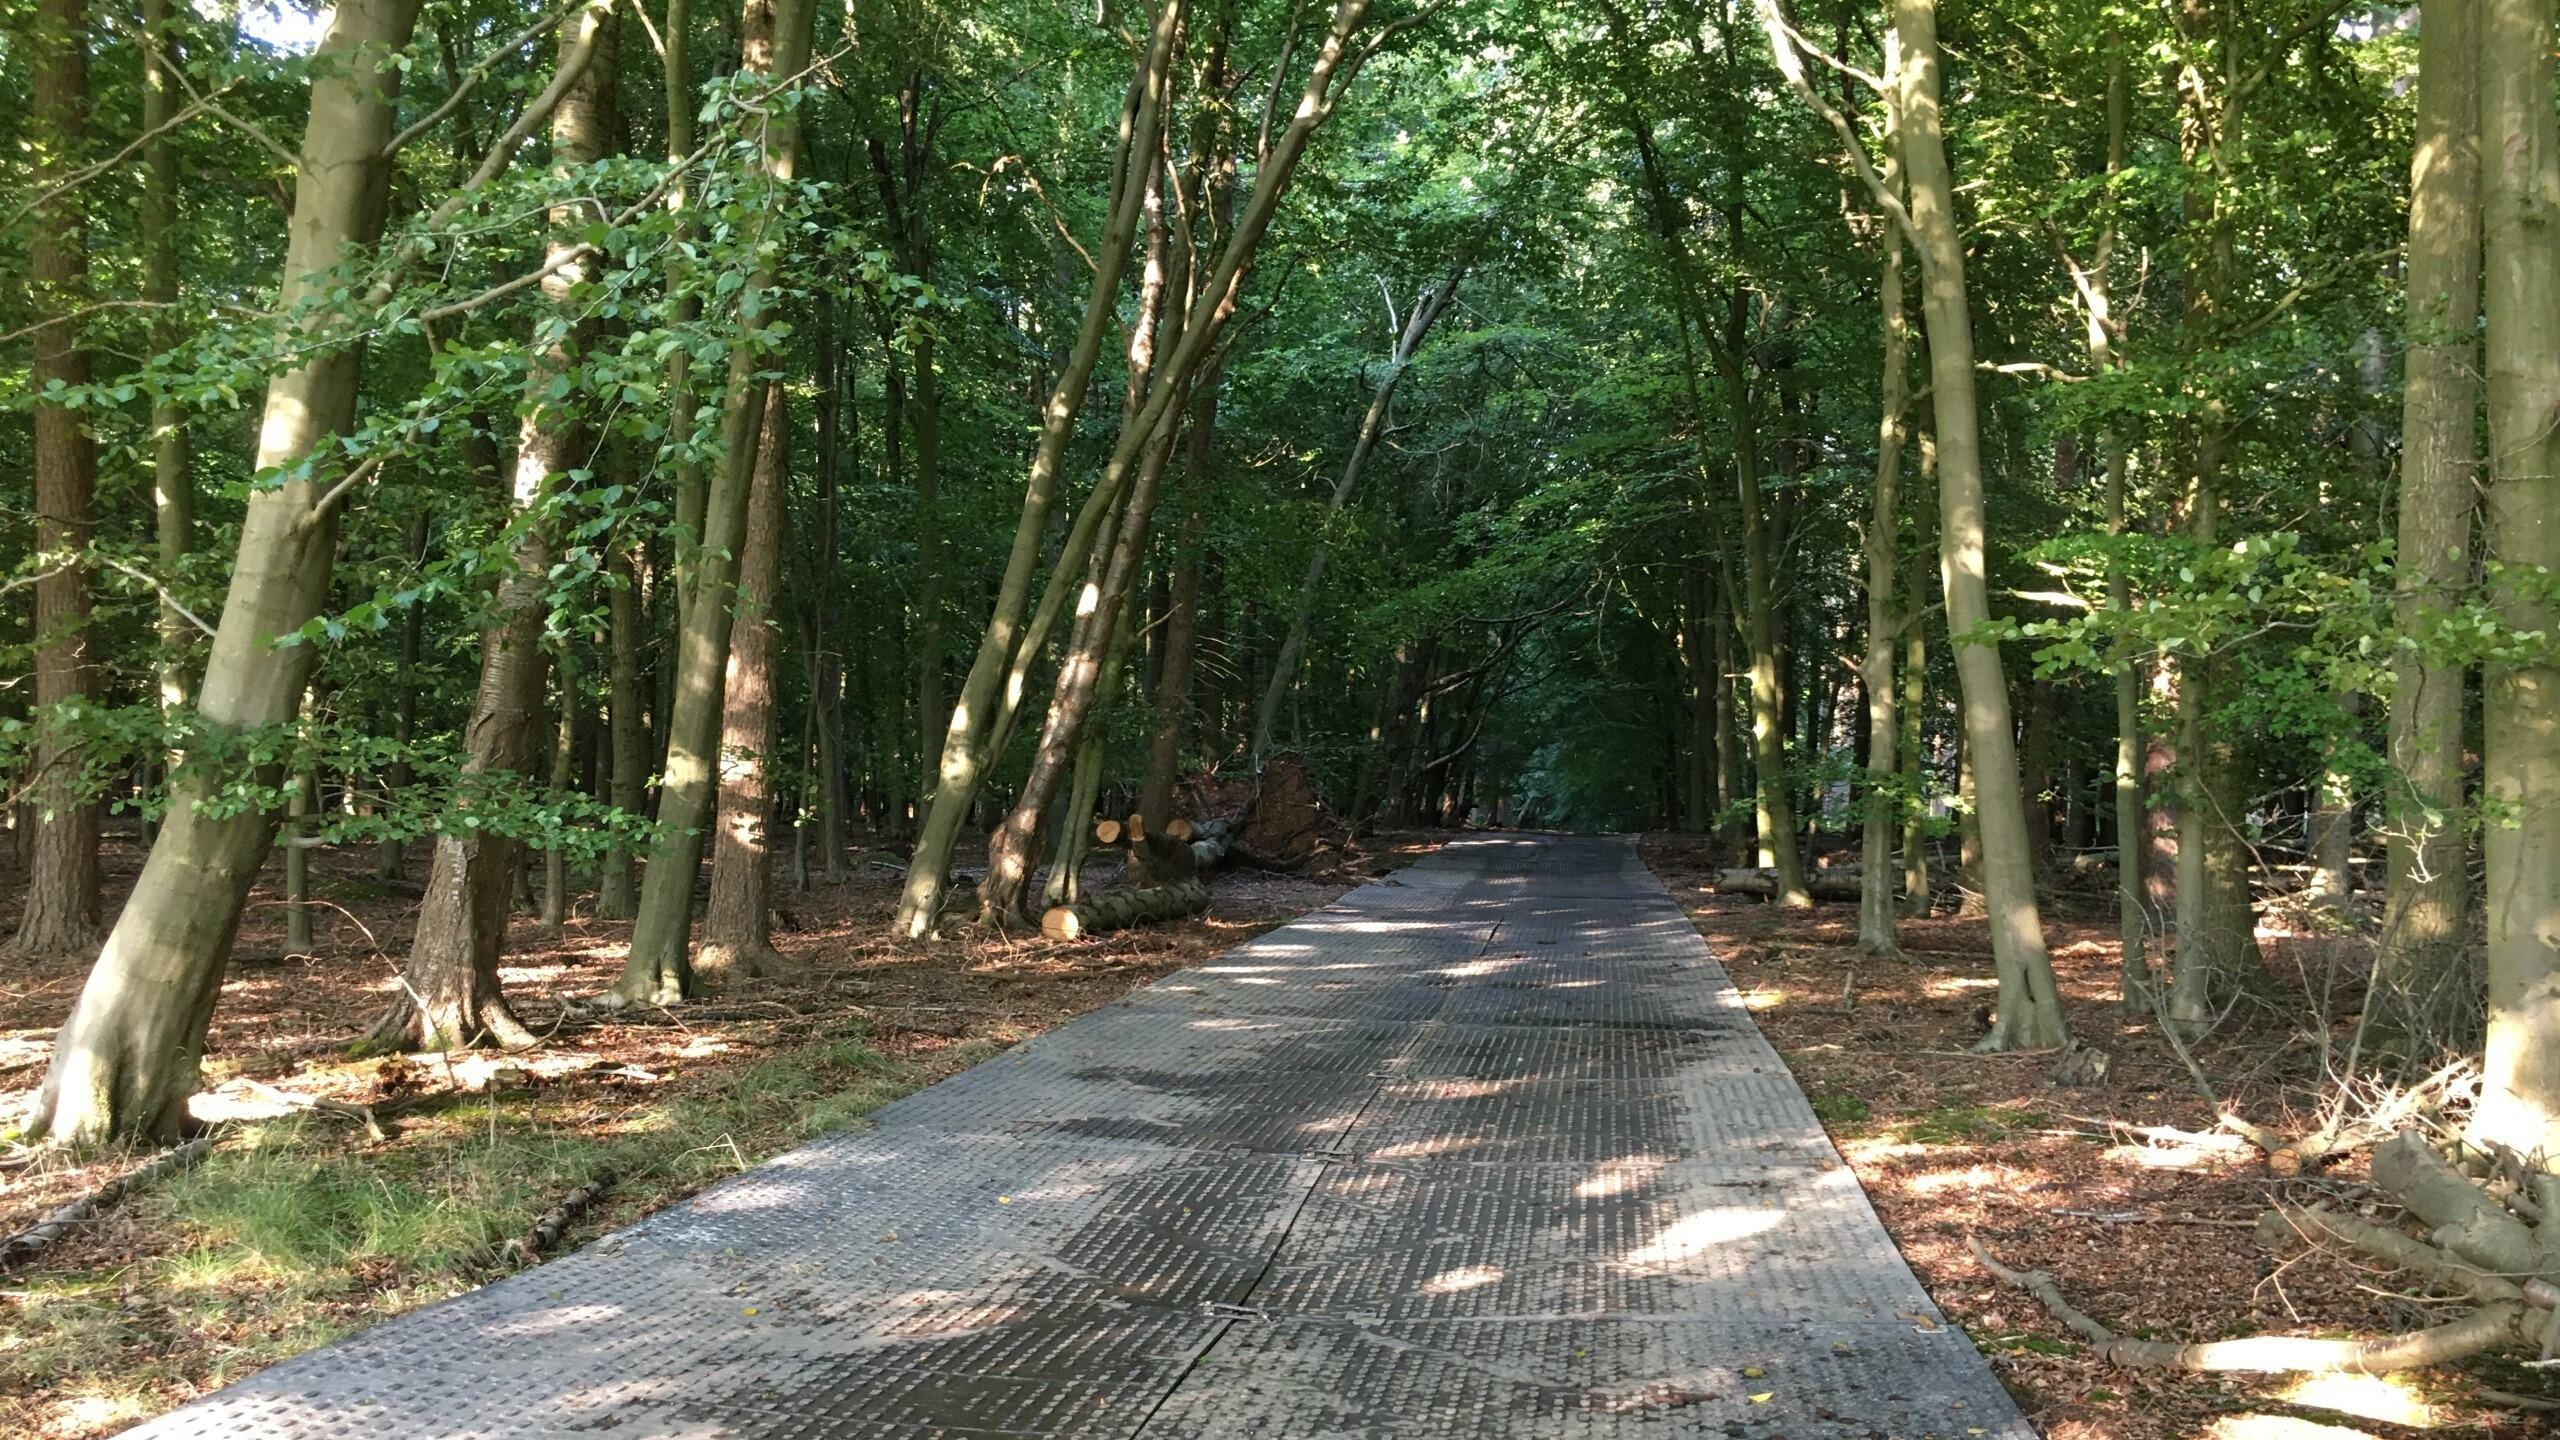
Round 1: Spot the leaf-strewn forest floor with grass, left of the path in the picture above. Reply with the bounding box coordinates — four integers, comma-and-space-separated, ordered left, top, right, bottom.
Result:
0, 835, 1439, 1440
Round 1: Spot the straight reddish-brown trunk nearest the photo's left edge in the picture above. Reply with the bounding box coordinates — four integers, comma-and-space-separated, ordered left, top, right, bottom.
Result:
13, 0, 97, 953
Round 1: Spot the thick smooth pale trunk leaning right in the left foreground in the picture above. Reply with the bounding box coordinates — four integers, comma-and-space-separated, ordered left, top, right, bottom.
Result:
26, 0, 420, 1143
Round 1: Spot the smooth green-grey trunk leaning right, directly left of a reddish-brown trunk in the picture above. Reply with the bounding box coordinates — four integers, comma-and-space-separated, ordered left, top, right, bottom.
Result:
596, 0, 817, 1010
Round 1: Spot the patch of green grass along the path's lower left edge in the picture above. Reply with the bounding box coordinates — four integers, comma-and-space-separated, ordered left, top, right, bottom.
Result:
0, 1027, 942, 1430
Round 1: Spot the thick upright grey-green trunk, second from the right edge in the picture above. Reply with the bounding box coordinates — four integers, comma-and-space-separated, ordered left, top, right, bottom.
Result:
2365, 0, 2481, 1043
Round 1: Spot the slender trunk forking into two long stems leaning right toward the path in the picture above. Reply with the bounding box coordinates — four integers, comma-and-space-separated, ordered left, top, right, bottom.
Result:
893, 0, 1370, 938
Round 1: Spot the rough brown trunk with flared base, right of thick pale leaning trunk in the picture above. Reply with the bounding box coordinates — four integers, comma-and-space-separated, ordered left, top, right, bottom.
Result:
374, 3, 614, 1051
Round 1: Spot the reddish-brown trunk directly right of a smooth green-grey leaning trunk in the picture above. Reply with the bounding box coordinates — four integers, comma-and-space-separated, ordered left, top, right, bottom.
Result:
694, 384, 791, 986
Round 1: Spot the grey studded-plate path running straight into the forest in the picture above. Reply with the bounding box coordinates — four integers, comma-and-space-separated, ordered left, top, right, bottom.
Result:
133, 835, 2033, 1440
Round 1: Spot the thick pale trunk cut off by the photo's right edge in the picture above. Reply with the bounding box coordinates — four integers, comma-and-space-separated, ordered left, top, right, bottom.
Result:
2470, 0, 2560, 1153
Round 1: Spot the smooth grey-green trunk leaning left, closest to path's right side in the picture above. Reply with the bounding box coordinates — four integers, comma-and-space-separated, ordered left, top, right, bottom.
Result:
1894, 0, 2071, 1051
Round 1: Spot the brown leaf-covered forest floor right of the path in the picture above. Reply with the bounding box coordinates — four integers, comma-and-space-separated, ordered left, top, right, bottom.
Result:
1644, 835, 2560, 1440
